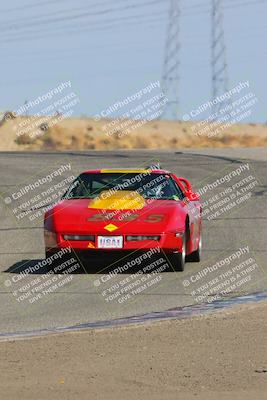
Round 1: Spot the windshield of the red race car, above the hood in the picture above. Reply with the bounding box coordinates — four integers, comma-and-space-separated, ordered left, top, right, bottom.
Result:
62, 173, 184, 200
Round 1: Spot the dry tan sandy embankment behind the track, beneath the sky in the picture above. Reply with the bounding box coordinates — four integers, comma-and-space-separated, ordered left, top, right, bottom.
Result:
0, 117, 267, 151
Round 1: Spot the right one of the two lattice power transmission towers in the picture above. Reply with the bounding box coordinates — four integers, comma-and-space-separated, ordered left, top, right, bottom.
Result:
211, 0, 229, 120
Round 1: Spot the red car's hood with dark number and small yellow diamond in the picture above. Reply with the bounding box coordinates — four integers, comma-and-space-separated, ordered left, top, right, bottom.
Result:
50, 199, 186, 234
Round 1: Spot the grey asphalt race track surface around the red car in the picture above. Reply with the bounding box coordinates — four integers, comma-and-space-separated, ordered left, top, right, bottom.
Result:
0, 149, 267, 333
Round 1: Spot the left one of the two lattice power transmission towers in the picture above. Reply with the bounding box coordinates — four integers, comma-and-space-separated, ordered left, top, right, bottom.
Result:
162, 0, 181, 119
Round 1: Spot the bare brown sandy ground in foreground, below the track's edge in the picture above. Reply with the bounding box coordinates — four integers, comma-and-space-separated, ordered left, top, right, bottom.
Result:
0, 302, 267, 400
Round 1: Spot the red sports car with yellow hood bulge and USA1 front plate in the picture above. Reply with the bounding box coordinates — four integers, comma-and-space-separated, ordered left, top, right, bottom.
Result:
44, 167, 202, 271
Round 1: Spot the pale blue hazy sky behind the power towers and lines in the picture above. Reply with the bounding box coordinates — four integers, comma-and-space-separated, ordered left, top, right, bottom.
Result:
0, 0, 267, 123
